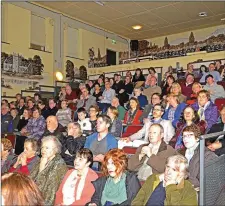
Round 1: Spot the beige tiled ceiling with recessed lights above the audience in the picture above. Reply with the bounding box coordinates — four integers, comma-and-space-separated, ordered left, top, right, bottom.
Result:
37, 1, 225, 39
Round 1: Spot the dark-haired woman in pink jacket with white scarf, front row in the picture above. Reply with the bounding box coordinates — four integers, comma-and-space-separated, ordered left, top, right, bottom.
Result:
55, 149, 98, 206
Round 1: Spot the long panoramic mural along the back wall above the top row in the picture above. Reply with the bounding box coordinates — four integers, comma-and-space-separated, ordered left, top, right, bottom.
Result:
119, 29, 225, 64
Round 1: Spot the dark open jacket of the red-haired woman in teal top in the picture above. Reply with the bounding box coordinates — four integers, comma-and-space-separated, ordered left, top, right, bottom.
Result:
87, 172, 141, 206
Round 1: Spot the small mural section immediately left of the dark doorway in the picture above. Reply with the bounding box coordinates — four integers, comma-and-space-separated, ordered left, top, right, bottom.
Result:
88, 47, 107, 68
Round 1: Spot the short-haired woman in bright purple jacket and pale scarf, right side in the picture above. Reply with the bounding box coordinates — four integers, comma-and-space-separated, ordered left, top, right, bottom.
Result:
192, 90, 218, 132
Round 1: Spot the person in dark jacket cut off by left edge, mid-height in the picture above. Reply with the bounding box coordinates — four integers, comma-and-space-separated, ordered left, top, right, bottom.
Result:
1, 104, 12, 133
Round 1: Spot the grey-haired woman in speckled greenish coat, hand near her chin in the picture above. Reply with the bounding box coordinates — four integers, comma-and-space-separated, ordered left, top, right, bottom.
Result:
30, 136, 67, 205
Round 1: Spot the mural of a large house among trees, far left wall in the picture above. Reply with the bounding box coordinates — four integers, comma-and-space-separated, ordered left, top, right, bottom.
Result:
1, 52, 44, 89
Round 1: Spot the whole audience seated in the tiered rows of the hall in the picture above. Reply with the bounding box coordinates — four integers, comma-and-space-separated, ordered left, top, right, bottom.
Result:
1, 63, 225, 206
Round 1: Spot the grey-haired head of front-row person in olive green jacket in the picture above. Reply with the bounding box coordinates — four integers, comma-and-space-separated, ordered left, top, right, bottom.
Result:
164, 154, 188, 184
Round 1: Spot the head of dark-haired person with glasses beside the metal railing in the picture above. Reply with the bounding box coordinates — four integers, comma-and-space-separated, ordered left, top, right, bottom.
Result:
182, 124, 201, 149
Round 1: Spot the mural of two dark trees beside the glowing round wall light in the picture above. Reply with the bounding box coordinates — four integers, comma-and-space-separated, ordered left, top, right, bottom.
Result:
66, 60, 87, 81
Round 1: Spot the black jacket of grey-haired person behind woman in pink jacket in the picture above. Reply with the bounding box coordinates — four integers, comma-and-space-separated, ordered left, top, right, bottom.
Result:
61, 136, 86, 166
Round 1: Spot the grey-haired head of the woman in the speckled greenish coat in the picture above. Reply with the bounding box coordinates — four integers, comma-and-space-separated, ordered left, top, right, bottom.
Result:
41, 136, 62, 160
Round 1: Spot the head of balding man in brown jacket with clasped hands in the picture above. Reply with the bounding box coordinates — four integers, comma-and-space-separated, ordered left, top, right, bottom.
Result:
148, 123, 164, 144
